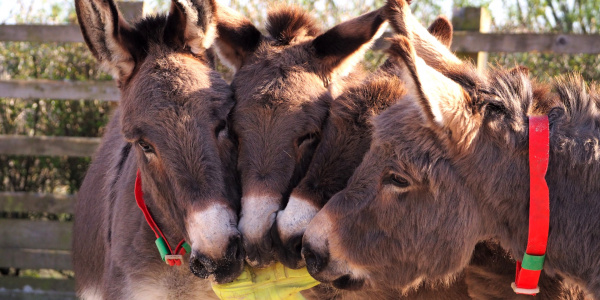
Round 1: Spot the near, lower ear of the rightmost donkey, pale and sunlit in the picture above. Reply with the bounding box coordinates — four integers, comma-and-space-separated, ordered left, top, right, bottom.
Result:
388, 36, 472, 142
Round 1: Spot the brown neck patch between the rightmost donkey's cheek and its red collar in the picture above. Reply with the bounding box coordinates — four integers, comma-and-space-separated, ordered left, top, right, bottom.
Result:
457, 140, 529, 258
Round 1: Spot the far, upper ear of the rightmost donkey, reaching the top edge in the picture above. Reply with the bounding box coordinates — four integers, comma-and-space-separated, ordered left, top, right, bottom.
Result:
384, 0, 462, 73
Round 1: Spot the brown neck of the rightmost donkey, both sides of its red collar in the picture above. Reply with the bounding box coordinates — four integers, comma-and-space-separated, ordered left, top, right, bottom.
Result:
460, 133, 600, 296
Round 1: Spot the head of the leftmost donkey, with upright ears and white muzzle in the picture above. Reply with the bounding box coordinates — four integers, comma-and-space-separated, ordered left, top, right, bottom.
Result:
76, 0, 243, 282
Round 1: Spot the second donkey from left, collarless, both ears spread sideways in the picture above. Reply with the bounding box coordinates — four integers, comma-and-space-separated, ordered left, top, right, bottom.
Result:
216, 7, 385, 267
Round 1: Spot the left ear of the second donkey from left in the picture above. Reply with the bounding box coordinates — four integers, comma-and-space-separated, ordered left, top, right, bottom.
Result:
215, 5, 263, 71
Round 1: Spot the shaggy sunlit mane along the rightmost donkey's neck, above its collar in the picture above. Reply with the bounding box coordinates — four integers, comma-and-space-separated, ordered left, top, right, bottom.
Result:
489, 69, 600, 166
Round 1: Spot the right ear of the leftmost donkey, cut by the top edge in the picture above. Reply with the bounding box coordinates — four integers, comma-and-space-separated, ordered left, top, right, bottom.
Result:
164, 0, 217, 54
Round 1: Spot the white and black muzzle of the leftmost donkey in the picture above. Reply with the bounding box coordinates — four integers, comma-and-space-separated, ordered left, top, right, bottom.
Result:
188, 206, 244, 283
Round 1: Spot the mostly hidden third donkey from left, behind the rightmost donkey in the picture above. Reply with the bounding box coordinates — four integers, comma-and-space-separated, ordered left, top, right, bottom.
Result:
274, 11, 577, 299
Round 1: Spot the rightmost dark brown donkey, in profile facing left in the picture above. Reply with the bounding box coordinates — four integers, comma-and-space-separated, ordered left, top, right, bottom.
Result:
303, 0, 600, 298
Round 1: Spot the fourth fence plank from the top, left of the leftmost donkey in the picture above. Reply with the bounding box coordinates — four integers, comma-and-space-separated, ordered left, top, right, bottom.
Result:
0, 192, 75, 214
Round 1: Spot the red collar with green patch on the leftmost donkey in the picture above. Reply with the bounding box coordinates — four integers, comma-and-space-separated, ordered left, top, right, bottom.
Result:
135, 170, 191, 266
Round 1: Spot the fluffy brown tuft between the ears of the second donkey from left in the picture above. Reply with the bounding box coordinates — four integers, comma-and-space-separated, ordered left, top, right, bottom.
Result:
266, 6, 321, 45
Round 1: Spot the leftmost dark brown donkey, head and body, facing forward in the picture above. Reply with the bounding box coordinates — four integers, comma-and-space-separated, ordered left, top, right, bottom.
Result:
73, 0, 243, 299
